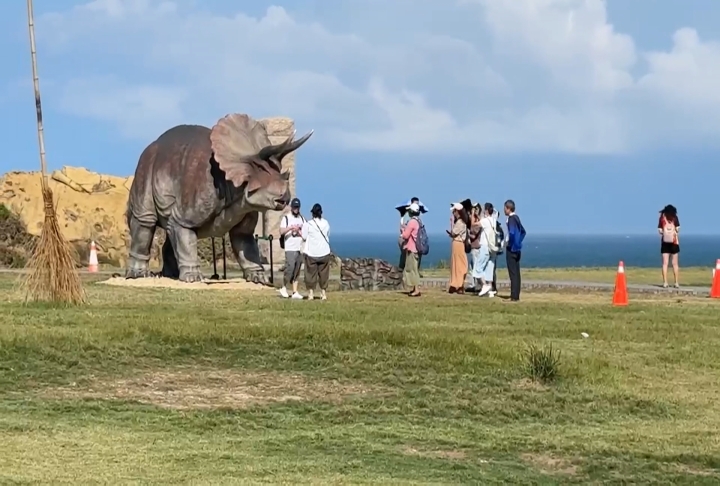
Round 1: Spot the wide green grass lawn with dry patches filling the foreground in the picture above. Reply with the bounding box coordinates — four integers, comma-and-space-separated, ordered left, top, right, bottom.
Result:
0, 276, 720, 485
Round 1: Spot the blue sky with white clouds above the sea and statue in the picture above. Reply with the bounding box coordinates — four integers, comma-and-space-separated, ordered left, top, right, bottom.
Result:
0, 0, 720, 234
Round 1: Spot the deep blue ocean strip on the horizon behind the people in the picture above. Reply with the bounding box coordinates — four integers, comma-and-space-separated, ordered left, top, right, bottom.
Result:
330, 234, 720, 268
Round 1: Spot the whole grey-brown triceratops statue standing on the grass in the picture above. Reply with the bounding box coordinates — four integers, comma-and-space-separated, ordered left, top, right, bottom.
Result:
125, 114, 312, 284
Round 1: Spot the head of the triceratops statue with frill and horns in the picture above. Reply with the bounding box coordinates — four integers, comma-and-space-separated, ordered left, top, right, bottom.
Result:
210, 113, 313, 211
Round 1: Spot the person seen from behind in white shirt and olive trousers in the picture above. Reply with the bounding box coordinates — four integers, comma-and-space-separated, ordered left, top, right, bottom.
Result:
302, 203, 332, 300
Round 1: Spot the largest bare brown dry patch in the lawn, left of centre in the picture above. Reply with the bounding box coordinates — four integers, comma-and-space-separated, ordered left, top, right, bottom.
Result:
42, 369, 386, 410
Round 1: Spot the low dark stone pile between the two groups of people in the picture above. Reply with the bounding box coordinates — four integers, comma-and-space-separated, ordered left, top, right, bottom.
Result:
340, 258, 403, 290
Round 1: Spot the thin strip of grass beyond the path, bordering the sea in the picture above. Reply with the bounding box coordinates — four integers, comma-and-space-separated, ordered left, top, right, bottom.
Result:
421, 266, 713, 287
